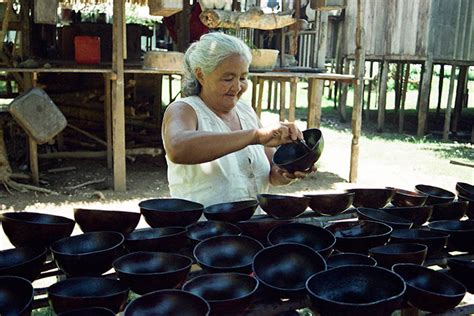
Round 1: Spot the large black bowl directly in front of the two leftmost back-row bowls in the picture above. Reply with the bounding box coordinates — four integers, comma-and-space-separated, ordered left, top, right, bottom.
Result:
50, 232, 124, 276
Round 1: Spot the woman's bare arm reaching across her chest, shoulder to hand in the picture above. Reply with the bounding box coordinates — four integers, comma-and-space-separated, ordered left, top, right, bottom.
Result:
162, 102, 301, 164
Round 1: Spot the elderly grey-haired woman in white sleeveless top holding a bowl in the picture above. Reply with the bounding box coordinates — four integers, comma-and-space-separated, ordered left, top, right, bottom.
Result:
162, 33, 314, 206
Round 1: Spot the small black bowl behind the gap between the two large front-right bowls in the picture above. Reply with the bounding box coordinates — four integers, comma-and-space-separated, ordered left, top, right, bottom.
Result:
369, 243, 428, 269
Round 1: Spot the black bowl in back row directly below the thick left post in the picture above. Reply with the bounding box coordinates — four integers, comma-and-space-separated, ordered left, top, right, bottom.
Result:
74, 208, 141, 235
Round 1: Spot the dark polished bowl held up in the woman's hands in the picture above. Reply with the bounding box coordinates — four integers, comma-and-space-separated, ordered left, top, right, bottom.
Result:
273, 128, 324, 173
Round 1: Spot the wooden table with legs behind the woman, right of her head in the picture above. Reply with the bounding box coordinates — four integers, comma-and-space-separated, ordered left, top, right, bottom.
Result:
250, 72, 355, 128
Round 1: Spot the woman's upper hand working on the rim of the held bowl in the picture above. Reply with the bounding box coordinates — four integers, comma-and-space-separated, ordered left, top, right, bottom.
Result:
256, 123, 303, 147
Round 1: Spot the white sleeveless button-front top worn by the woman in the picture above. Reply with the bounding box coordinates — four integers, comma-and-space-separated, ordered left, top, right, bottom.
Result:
166, 96, 270, 206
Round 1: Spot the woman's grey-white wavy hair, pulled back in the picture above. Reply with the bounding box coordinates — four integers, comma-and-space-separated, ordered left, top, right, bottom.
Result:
182, 32, 252, 97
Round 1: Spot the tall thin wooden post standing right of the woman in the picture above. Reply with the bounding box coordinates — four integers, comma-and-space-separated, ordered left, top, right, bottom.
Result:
349, 0, 365, 183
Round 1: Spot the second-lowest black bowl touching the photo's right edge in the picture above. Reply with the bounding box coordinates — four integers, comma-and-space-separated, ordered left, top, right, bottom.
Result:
428, 220, 474, 252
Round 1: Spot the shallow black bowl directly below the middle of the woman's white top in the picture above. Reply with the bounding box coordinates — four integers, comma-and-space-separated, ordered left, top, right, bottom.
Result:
204, 200, 258, 223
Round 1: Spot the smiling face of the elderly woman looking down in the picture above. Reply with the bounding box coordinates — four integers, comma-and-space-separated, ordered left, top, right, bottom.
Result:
196, 55, 249, 112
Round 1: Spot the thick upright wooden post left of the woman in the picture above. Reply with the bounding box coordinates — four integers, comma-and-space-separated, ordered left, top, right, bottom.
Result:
112, 0, 126, 191
